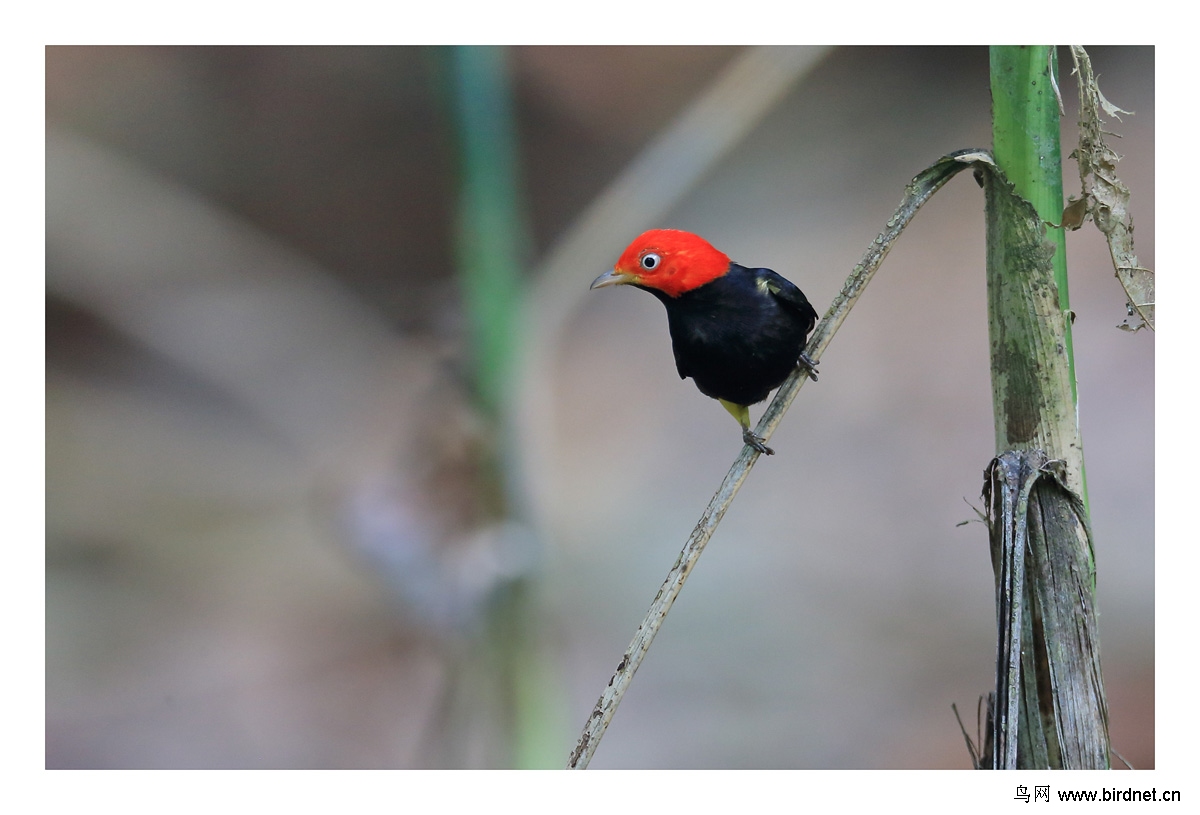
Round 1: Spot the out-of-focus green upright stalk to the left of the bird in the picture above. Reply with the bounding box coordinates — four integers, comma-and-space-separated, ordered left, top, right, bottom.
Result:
450, 47, 564, 768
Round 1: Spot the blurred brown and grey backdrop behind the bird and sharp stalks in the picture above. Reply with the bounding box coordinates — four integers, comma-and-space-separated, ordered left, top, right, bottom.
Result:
46, 47, 1154, 768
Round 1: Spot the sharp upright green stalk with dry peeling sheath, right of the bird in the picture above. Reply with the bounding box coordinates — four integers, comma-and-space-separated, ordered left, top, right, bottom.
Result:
982, 47, 1109, 769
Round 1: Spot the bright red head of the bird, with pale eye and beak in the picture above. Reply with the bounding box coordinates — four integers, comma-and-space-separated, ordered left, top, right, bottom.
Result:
592, 229, 730, 298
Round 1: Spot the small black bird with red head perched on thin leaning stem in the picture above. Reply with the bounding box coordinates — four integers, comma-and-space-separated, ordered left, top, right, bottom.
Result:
590, 229, 817, 456
